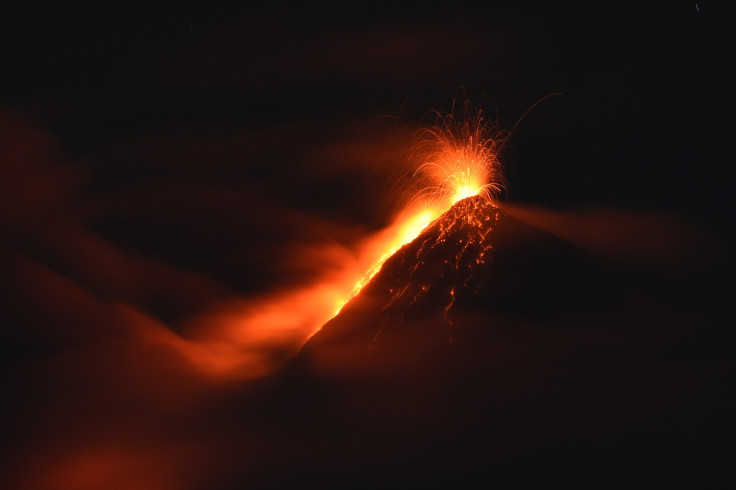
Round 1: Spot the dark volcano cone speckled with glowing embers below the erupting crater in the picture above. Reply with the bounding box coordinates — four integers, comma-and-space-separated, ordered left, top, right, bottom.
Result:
302, 195, 615, 368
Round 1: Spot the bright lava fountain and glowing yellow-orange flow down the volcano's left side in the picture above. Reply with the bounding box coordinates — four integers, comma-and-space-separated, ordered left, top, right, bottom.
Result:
328, 101, 508, 315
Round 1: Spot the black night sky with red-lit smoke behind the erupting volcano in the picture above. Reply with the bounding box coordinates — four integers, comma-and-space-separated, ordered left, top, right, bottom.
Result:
0, 1, 736, 489
